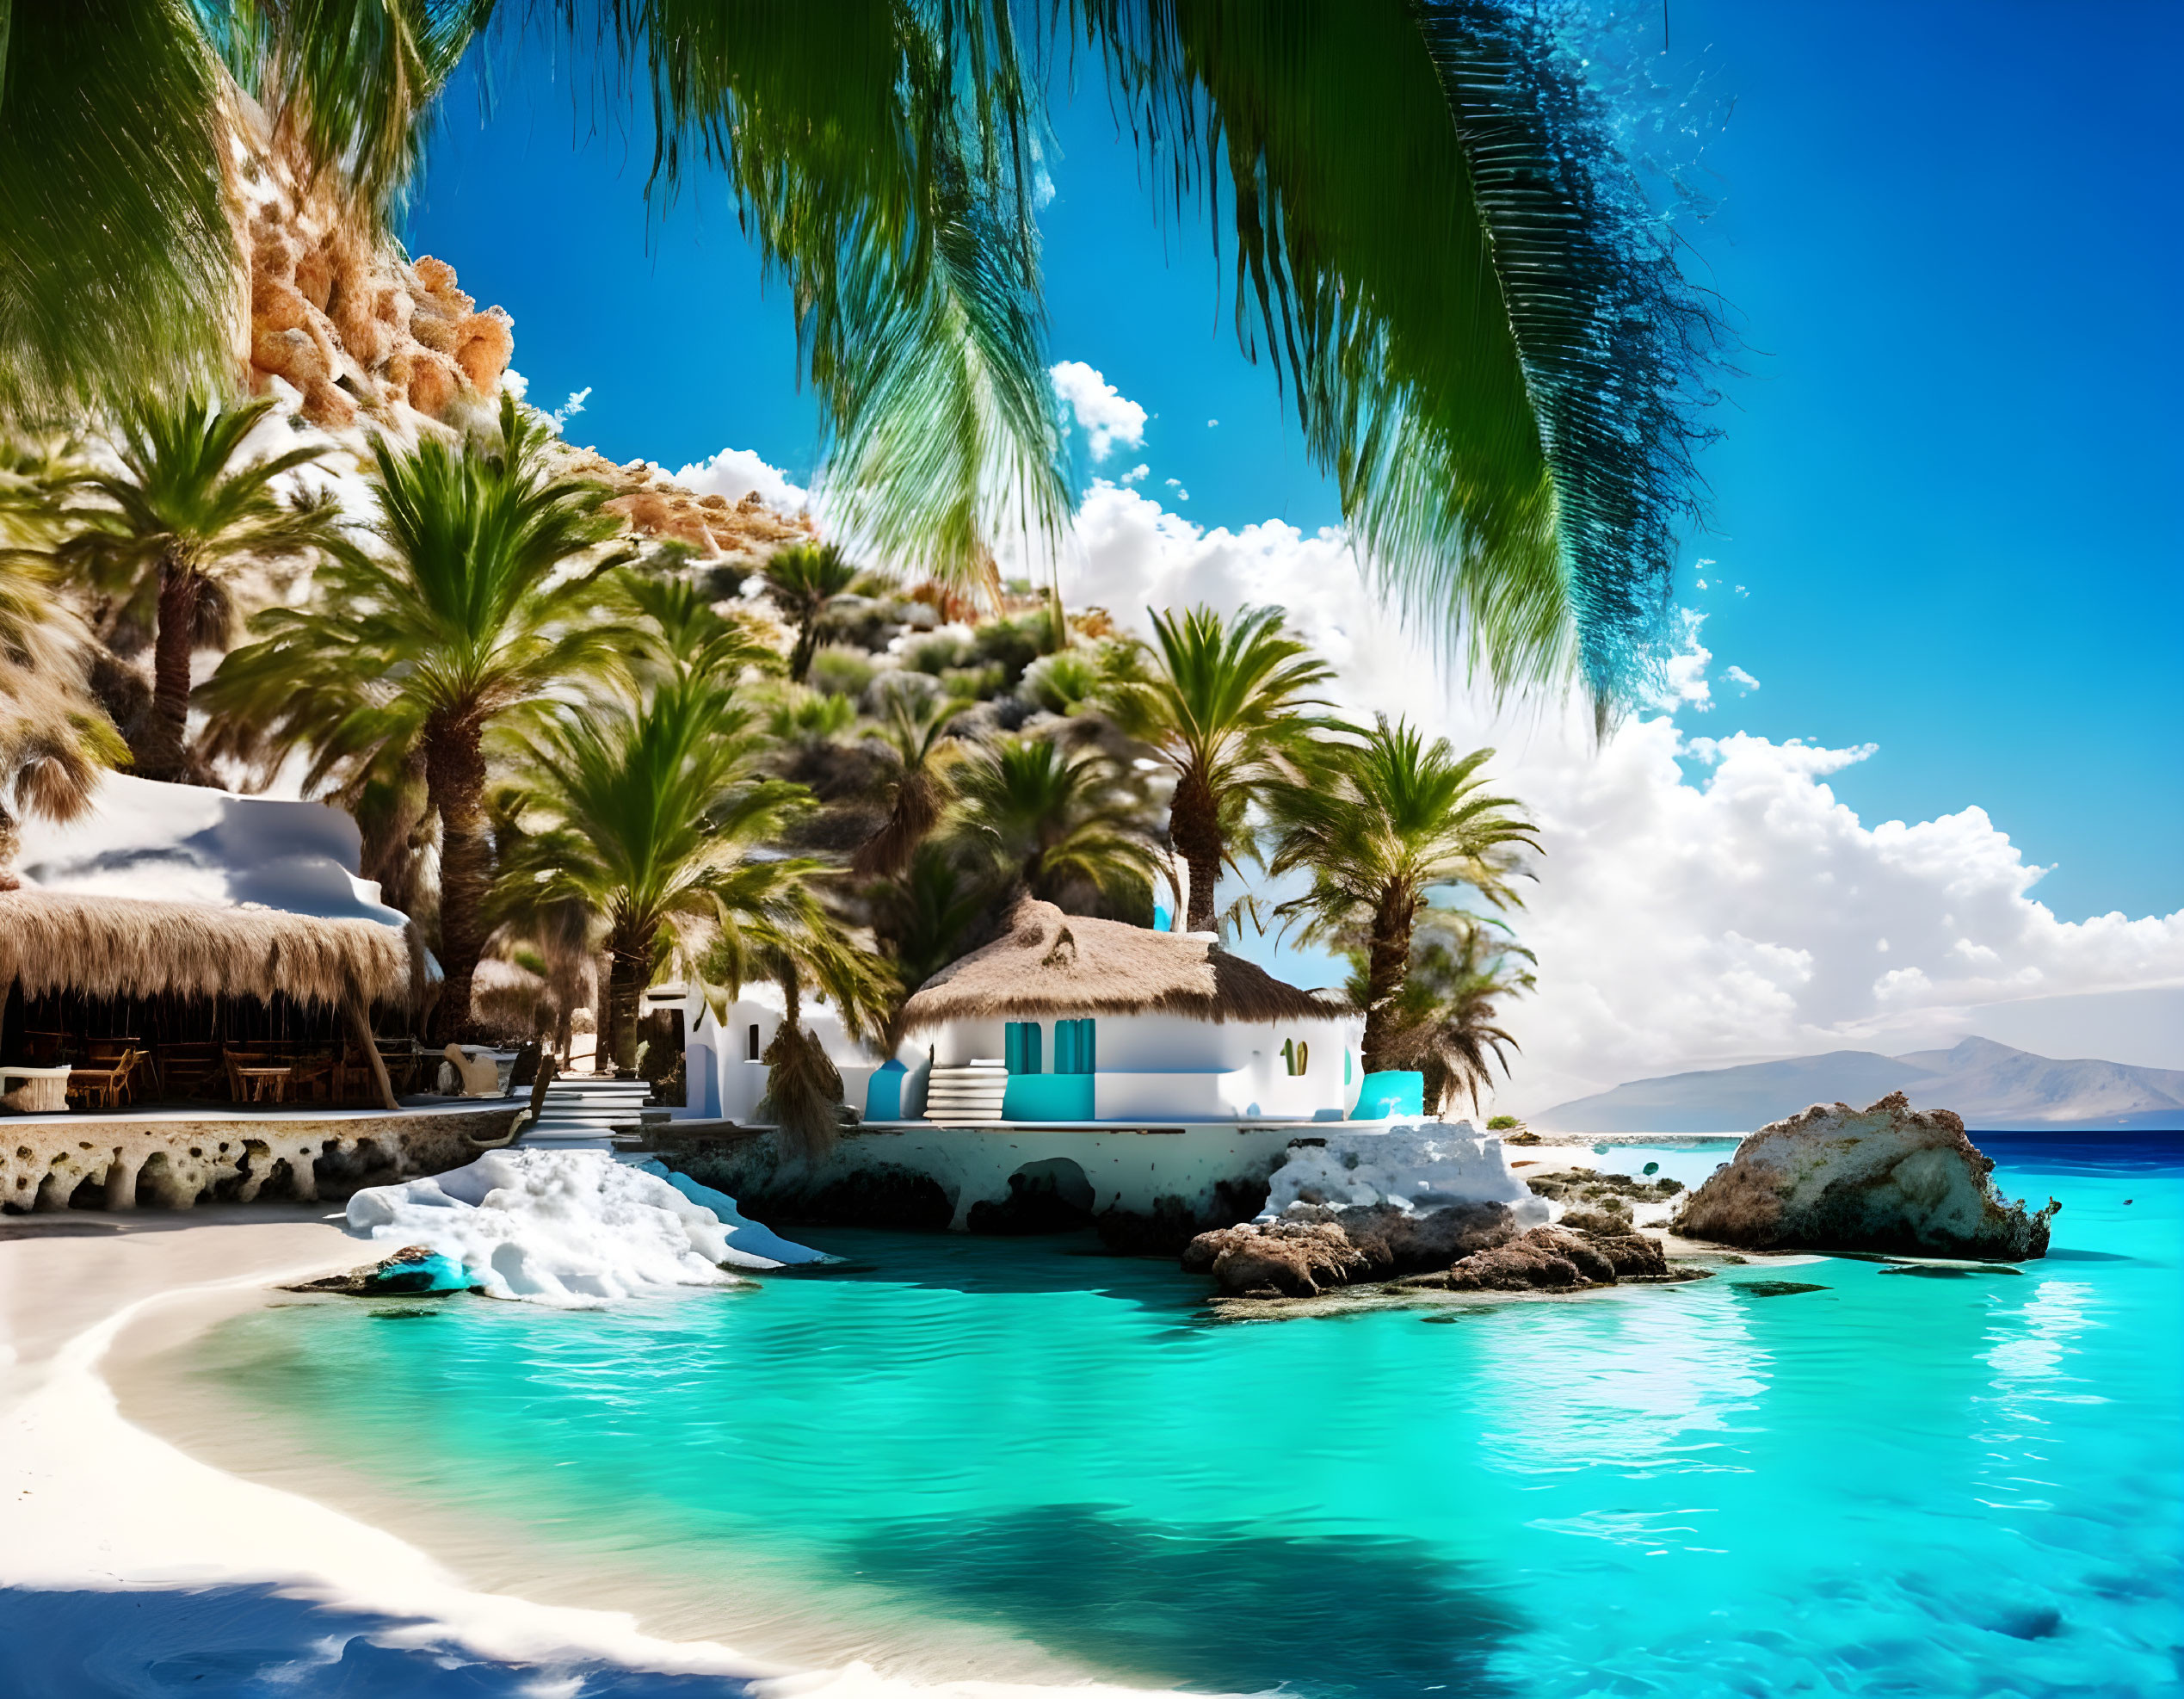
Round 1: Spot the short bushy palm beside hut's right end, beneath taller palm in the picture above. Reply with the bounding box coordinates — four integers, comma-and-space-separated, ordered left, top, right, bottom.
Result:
1348, 913, 1538, 1116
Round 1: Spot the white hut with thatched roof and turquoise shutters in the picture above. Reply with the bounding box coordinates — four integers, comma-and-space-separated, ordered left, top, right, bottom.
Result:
904, 902, 1360, 1122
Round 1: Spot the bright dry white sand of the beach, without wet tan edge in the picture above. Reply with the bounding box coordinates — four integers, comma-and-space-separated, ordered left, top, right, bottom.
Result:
0, 1206, 861, 1690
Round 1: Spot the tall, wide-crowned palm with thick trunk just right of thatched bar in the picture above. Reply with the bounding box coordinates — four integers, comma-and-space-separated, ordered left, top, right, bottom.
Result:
206, 399, 633, 1037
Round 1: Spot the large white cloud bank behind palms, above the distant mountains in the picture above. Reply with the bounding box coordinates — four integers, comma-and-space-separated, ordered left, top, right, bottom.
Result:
1064, 480, 2184, 1109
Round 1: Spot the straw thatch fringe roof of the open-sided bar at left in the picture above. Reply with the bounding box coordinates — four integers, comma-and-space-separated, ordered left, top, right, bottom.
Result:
0, 889, 430, 1004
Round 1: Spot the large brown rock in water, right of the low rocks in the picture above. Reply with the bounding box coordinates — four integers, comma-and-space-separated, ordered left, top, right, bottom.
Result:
1675, 1092, 2062, 1263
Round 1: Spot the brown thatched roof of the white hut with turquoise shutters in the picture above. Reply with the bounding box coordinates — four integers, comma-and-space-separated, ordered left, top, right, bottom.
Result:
902, 902, 1343, 1031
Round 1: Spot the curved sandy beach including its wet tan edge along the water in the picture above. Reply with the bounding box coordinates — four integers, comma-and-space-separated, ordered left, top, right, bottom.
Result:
0, 1140, 1755, 1695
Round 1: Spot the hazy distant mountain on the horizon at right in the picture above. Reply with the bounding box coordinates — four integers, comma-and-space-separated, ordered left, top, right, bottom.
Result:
1527, 1037, 2184, 1134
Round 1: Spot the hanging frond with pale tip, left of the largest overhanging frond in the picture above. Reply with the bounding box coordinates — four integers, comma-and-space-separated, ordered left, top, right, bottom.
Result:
561, 0, 1070, 590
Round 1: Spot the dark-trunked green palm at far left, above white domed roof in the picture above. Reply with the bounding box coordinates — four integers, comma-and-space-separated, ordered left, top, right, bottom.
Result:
54, 395, 342, 782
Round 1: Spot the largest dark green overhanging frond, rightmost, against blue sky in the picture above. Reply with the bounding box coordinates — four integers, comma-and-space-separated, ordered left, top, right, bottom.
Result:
1083, 0, 1718, 712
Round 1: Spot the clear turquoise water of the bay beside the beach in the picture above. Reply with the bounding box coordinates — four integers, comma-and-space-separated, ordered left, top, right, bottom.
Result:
201, 1140, 2184, 1699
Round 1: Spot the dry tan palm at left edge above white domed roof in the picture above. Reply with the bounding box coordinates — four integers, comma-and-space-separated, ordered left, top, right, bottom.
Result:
0, 439, 129, 891
